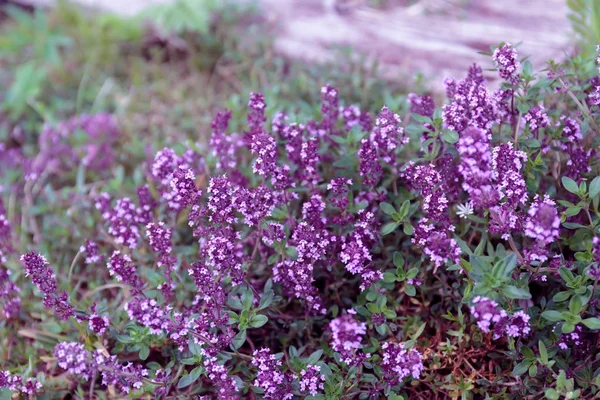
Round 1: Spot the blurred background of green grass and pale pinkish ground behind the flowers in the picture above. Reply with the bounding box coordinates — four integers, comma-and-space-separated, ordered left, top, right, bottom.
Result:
0, 0, 600, 145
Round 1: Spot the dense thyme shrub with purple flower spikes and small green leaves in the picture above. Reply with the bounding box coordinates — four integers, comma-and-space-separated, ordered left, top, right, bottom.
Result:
0, 44, 600, 400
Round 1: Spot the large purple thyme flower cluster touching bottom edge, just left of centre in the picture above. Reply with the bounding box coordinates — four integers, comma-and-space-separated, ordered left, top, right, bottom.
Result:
252, 348, 294, 400
